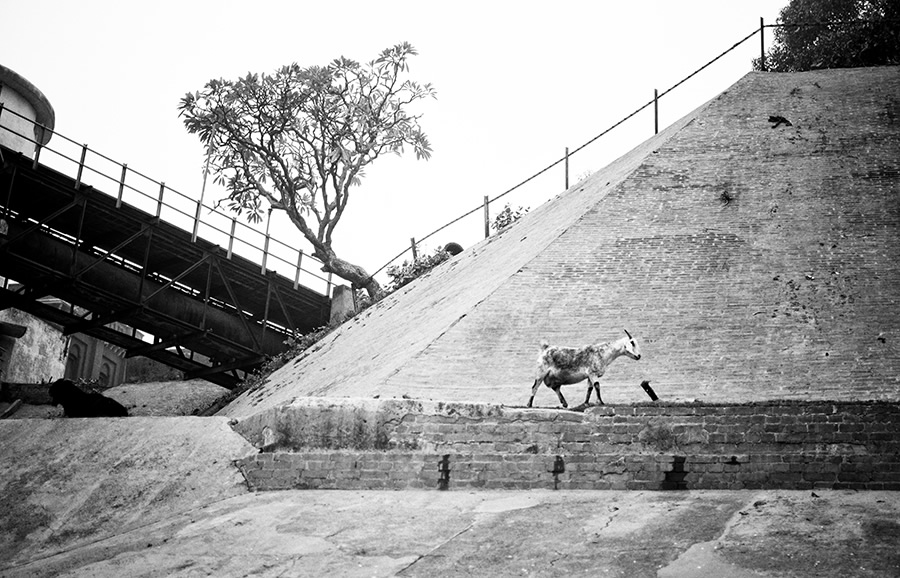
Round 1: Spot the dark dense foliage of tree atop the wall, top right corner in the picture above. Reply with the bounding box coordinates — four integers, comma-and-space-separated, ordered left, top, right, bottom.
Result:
753, 0, 900, 72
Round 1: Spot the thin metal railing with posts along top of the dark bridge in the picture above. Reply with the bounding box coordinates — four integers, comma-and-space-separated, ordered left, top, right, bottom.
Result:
0, 103, 342, 297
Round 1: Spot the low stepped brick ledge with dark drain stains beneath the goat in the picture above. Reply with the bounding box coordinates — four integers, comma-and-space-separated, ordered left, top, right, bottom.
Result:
235, 399, 900, 490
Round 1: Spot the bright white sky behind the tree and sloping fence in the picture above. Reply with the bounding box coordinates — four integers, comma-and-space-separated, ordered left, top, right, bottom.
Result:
0, 0, 788, 282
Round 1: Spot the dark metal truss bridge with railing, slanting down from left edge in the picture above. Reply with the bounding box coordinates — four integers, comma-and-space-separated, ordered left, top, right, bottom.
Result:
0, 108, 332, 388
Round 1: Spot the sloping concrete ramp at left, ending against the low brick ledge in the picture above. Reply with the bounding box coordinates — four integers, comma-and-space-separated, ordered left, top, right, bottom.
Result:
0, 417, 256, 569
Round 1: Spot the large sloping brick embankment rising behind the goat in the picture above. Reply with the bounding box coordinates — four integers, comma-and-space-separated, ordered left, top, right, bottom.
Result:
223, 67, 900, 417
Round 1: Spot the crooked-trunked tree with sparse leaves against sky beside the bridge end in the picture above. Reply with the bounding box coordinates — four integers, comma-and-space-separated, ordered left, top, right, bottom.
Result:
179, 43, 435, 298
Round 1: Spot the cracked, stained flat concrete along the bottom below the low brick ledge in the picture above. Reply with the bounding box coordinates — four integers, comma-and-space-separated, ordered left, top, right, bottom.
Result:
0, 491, 900, 578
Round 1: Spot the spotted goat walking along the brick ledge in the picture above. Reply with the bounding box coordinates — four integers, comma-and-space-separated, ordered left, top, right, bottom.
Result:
528, 329, 641, 407
